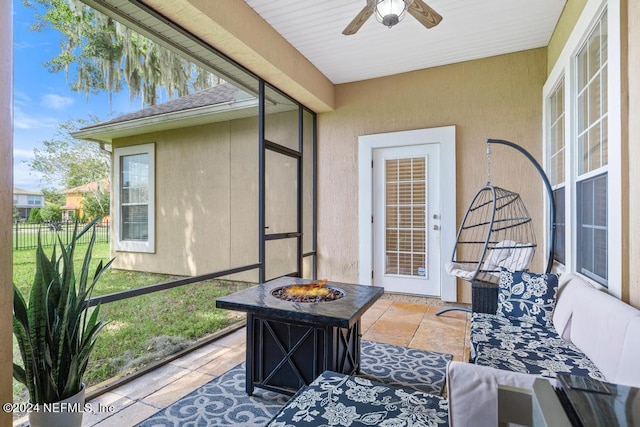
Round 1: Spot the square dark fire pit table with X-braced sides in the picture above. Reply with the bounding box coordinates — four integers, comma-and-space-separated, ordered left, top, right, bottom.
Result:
216, 277, 384, 395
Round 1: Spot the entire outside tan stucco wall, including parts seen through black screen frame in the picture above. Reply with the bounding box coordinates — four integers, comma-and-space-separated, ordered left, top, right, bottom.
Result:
113, 110, 312, 281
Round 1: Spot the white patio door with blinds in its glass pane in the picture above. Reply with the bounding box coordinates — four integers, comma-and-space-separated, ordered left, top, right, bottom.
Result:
372, 143, 441, 297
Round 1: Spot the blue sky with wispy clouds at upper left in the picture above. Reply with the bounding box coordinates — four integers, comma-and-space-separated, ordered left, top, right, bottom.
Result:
13, 0, 140, 190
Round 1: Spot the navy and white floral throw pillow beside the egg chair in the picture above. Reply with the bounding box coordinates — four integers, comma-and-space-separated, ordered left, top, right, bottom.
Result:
496, 268, 558, 327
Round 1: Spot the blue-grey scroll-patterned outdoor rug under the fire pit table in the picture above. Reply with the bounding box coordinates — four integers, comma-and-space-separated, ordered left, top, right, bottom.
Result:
139, 340, 451, 427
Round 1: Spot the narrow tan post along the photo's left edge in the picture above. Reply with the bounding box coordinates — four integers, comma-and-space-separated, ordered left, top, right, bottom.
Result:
0, 2, 13, 427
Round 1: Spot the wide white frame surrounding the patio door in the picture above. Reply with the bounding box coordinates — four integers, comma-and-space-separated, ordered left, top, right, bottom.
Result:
358, 126, 457, 301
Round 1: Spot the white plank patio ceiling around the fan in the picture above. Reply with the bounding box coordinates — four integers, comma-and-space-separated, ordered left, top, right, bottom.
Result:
245, 0, 565, 84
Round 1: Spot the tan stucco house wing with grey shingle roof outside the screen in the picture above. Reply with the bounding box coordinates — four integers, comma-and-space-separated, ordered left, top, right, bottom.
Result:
74, 83, 298, 280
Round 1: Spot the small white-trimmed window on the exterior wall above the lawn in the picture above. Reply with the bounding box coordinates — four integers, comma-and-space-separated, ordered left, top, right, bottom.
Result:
114, 144, 155, 252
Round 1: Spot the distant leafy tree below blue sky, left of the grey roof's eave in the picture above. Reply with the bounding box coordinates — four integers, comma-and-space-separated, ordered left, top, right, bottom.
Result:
29, 120, 111, 189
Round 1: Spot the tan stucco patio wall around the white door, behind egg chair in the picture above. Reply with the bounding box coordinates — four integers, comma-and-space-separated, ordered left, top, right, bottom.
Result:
318, 49, 546, 302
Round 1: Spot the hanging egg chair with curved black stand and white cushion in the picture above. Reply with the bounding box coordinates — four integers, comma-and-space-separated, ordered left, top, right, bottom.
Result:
436, 139, 555, 315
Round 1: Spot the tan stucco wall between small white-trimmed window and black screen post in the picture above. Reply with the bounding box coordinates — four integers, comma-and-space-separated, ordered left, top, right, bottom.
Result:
114, 119, 258, 276
